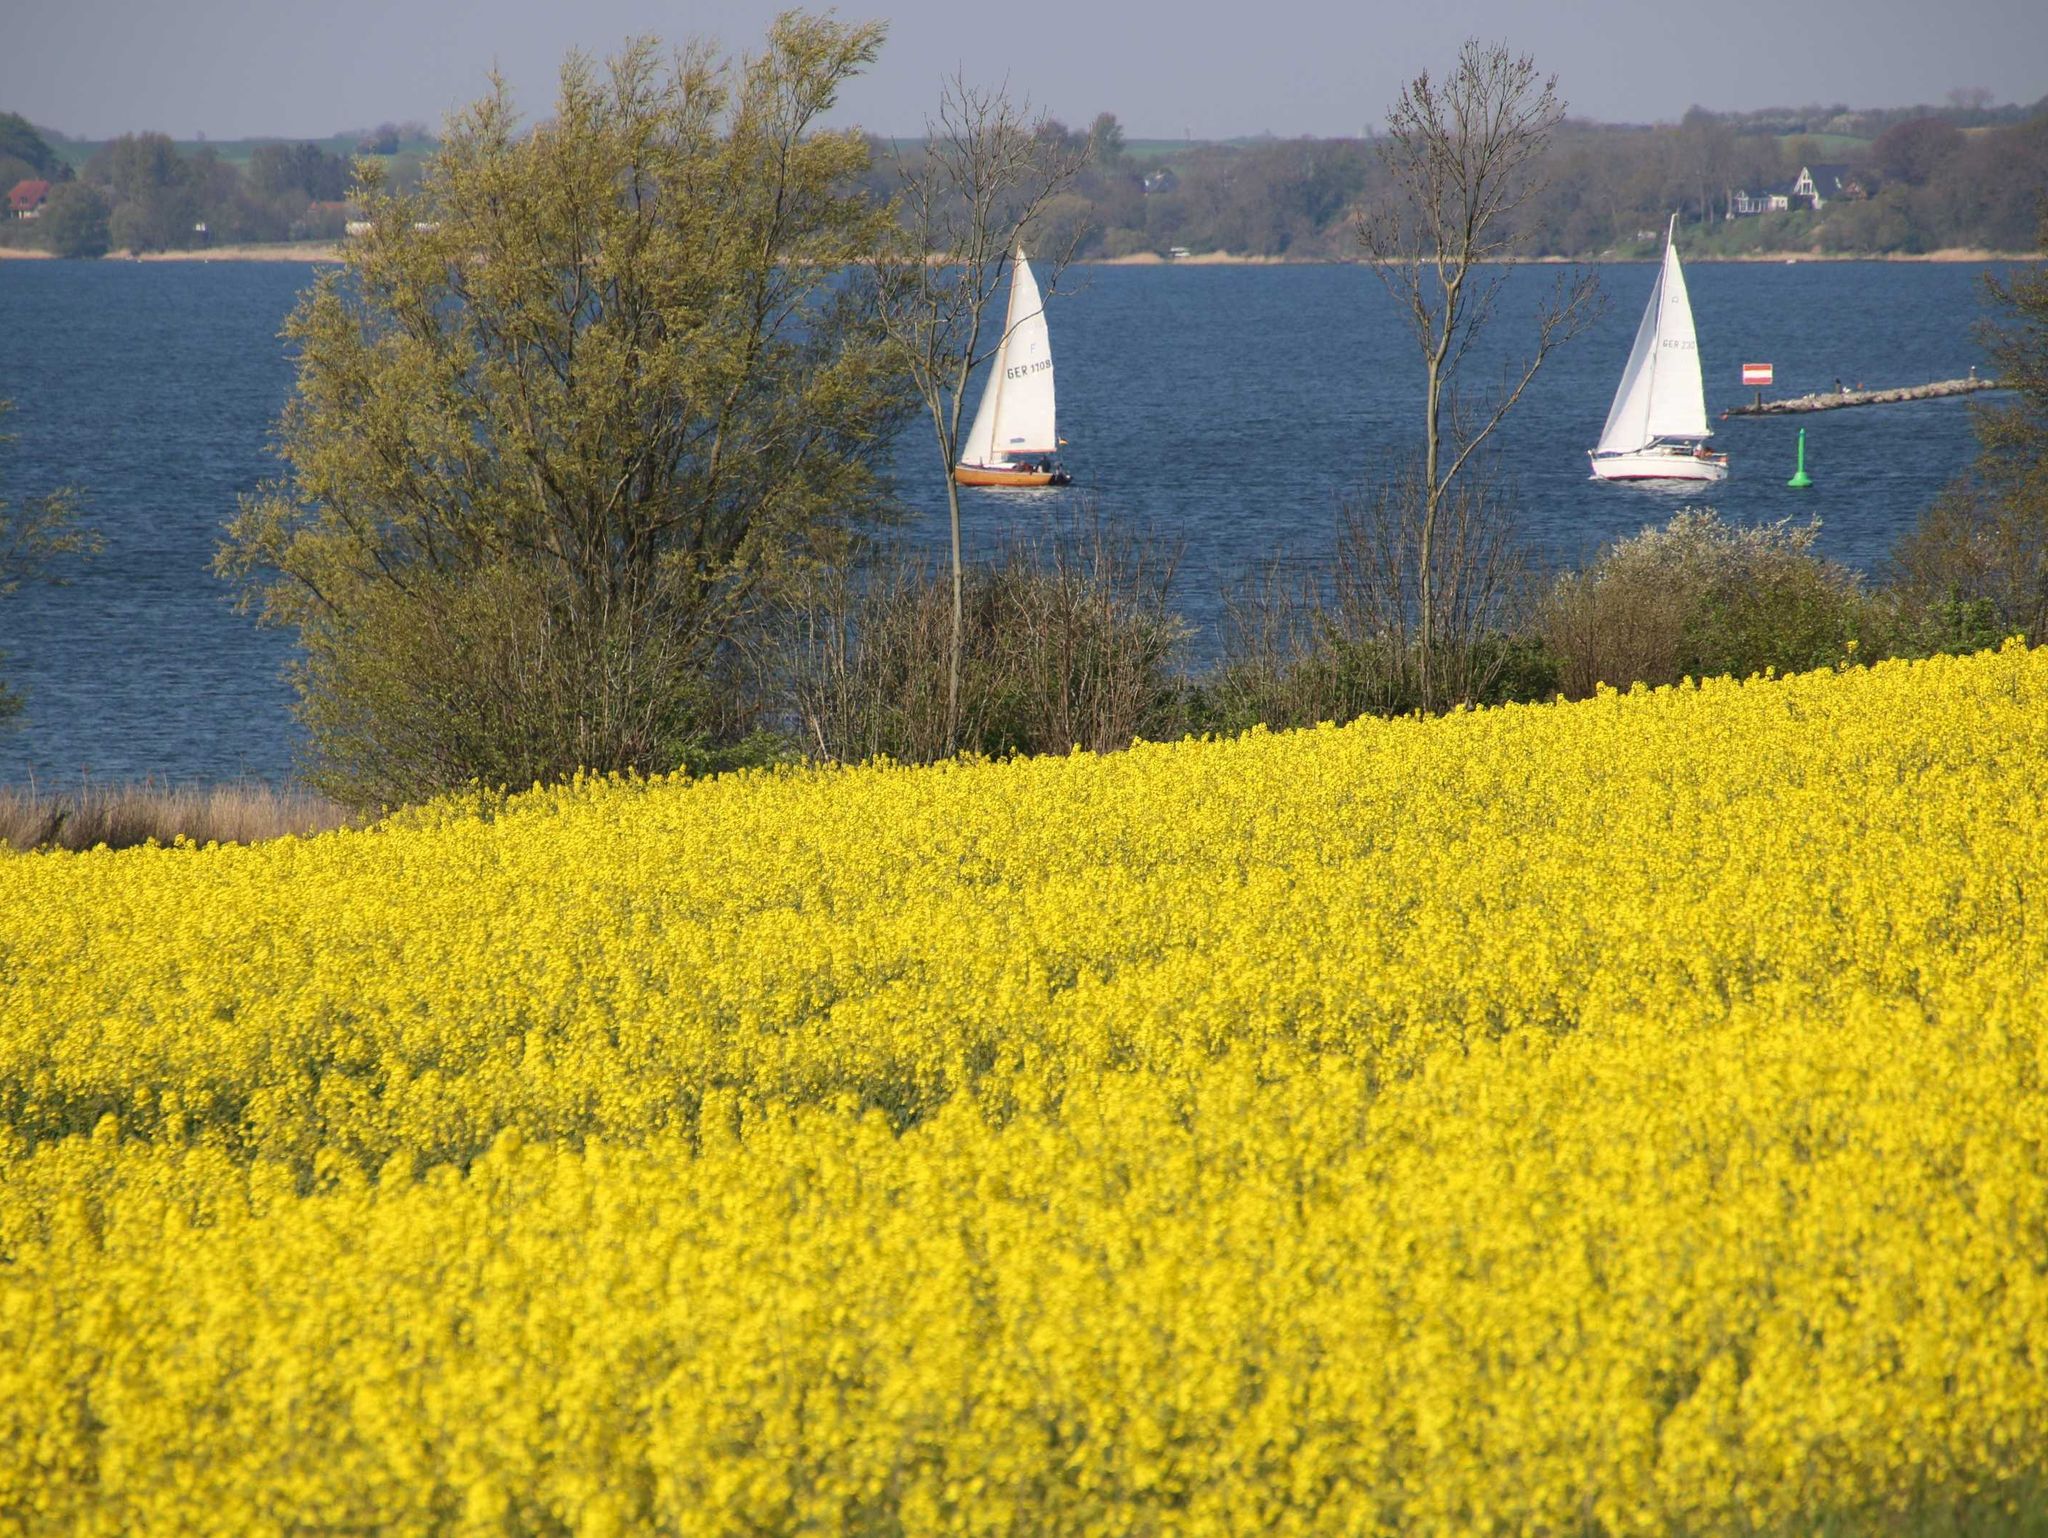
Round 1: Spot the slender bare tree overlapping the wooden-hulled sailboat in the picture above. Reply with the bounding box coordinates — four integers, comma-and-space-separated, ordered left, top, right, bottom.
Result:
877, 74, 1090, 752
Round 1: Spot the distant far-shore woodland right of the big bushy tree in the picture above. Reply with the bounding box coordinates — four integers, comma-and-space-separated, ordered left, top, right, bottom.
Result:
851, 92, 2048, 260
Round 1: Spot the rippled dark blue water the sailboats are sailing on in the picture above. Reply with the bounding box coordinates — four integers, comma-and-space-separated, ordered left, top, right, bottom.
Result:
0, 262, 2015, 784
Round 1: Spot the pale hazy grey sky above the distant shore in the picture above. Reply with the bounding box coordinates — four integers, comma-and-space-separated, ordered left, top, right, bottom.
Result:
0, 0, 2048, 139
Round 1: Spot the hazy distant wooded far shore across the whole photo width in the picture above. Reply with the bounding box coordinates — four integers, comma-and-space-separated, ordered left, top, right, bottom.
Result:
0, 90, 2048, 260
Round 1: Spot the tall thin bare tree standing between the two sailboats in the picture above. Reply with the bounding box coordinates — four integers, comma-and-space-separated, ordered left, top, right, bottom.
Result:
1358, 39, 1599, 711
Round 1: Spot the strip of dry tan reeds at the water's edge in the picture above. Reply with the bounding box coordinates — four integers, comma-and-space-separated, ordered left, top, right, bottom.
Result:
0, 780, 354, 850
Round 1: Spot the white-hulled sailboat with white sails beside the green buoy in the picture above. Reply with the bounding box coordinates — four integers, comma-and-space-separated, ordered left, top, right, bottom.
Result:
1589, 213, 1729, 481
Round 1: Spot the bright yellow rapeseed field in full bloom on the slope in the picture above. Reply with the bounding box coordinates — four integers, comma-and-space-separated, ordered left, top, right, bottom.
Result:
0, 647, 2048, 1534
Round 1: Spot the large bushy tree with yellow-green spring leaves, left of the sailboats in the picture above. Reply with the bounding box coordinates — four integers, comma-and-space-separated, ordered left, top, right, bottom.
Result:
217, 12, 901, 803
